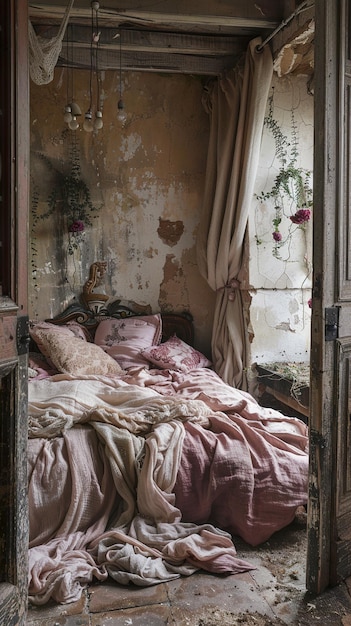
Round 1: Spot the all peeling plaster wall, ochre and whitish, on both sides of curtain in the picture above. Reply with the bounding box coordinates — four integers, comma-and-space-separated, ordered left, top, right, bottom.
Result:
30, 69, 313, 362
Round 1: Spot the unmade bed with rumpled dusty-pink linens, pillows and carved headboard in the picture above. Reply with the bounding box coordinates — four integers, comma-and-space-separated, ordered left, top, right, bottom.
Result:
28, 264, 308, 605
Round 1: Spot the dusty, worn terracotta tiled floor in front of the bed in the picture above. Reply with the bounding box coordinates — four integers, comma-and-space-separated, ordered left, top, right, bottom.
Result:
27, 518, 351, 626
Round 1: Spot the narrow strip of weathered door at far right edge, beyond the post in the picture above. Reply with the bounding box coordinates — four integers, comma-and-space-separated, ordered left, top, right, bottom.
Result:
332, 0, 351, 582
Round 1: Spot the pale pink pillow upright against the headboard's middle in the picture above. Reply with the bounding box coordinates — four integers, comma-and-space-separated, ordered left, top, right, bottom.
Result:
94, 313, 162, 369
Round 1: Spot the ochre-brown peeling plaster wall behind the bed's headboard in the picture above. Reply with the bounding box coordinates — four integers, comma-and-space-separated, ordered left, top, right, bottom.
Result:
30, 69, 214, 354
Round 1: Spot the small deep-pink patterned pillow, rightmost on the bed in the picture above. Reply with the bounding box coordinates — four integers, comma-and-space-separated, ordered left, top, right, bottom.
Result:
142, 336, 212, 372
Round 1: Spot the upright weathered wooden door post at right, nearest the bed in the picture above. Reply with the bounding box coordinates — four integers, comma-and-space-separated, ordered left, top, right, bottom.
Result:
306, 0, 349, 594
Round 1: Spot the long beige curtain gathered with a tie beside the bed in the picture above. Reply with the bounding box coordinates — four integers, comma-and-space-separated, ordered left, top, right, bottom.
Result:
197, 39, 273, 389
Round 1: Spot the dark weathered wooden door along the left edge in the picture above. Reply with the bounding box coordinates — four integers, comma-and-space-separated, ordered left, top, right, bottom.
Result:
0, 0, 29, 626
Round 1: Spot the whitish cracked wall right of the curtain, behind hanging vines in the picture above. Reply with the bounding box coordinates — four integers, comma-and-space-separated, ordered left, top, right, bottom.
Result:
249, 77, 316, 363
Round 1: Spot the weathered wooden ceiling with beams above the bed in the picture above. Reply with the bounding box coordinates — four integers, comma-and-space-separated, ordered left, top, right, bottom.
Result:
29, 0, 306, 75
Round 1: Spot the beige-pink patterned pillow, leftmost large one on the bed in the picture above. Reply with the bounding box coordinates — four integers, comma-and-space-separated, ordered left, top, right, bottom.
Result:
29, 329, 123, 376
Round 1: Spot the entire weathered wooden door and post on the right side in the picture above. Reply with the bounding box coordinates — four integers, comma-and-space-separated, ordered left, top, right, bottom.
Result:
307, 0, 351, 593
